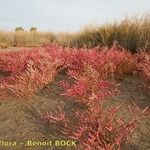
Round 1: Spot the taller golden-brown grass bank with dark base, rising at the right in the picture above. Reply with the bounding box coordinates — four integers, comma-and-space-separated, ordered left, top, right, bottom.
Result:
58, 15, 150, 52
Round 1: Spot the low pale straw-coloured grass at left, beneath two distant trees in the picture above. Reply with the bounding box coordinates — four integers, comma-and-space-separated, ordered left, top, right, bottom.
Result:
0, 31, 55, 48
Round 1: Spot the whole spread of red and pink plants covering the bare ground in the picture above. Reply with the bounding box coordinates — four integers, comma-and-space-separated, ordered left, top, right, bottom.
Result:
0, 44, 149, 150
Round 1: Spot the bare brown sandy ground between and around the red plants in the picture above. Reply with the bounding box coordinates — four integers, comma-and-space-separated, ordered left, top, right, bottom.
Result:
0, 75, 150, 150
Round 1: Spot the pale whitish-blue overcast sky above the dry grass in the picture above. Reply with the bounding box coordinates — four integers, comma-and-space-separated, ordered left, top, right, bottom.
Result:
0, 0, 150, 32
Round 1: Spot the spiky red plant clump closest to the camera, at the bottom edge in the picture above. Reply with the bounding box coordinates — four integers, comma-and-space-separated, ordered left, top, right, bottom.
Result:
43, 104, 146, 150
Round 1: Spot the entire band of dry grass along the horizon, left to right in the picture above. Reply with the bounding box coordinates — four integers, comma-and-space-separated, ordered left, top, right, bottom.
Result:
0, 15, 150, 52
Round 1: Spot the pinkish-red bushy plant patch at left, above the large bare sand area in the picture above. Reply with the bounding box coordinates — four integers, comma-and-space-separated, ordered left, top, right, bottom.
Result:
0, 47, 64, 99
